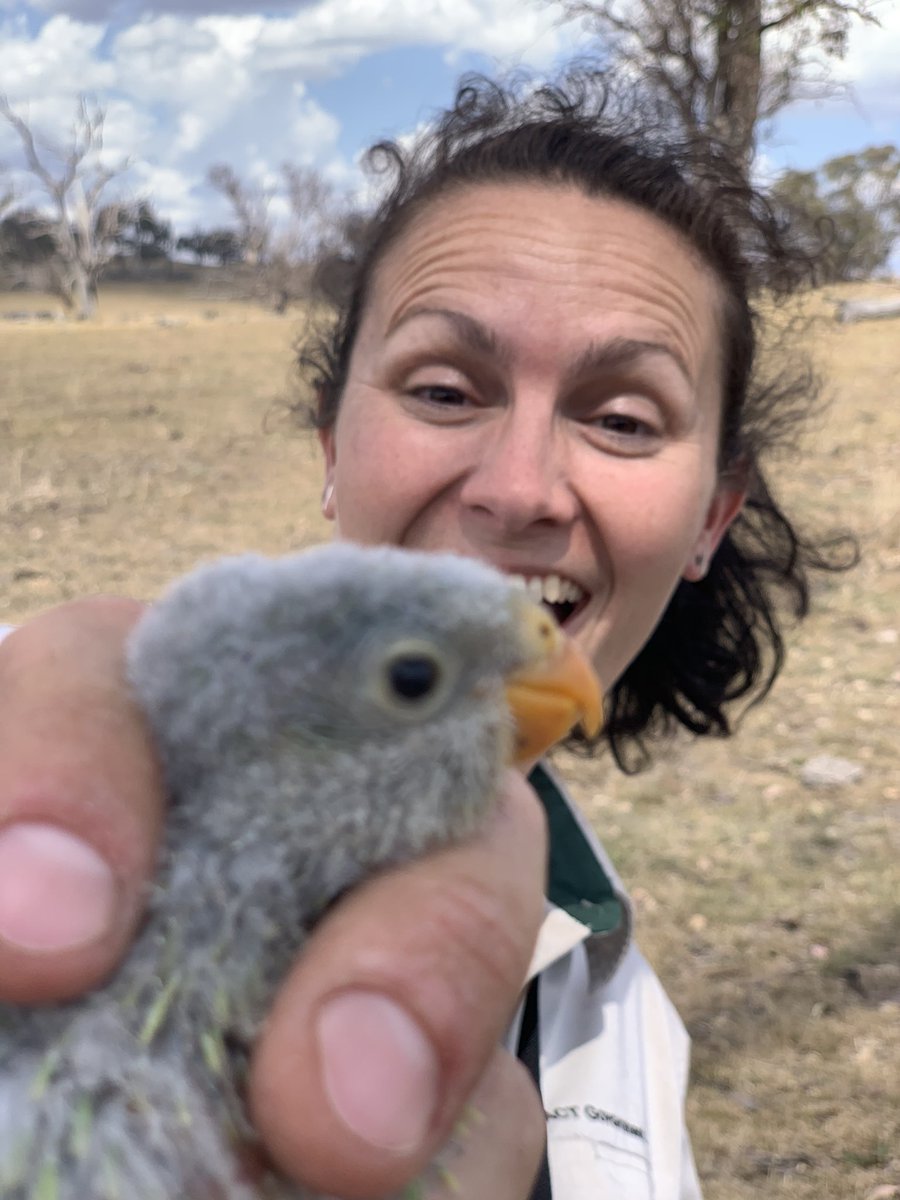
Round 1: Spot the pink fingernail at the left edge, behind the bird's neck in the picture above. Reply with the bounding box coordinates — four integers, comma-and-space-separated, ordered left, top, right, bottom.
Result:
0, 822, 116, 952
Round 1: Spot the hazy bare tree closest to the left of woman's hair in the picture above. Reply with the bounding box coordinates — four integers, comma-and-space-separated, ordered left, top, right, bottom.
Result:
208, 163, 348, 312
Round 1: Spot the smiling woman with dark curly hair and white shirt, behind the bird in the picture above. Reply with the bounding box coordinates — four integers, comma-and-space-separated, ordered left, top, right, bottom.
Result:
285, 76, 852, 1200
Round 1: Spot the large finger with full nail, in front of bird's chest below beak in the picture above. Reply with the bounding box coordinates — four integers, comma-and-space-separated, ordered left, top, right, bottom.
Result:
251, 772, 546, 1200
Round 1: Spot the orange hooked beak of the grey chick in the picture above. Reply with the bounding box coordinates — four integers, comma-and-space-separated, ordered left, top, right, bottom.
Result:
505, 593, 604, 764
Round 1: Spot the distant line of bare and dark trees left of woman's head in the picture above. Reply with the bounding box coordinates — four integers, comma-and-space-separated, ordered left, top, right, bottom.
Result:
0, 95, 365, 318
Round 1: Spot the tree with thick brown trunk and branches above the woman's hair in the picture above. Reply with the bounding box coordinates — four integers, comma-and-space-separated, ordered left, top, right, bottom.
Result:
550, 0, 878, 166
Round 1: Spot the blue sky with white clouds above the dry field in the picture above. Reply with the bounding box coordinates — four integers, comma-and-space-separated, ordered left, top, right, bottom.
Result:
0, 0, 900, 233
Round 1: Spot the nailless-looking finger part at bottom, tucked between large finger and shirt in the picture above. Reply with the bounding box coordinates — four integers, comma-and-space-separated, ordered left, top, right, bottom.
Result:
424, 1049, 547, 1200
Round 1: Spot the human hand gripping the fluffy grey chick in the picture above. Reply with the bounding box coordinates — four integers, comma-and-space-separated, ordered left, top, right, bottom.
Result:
0, 600, 545, 1200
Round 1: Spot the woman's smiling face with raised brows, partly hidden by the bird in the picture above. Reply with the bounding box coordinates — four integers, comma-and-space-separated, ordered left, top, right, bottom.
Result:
323, 177, 743, 686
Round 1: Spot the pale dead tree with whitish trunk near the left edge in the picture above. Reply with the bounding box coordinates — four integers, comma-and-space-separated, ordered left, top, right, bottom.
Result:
0, 96, 130, 318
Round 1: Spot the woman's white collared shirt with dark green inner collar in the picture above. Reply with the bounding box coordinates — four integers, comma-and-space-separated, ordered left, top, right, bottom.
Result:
506, 764, 700, 1200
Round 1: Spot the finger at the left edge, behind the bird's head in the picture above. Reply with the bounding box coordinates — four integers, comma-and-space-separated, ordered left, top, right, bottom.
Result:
0, 599, 163, 1003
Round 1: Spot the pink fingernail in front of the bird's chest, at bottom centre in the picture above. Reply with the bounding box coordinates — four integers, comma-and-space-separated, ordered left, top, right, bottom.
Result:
317, 991, 439, 1152
